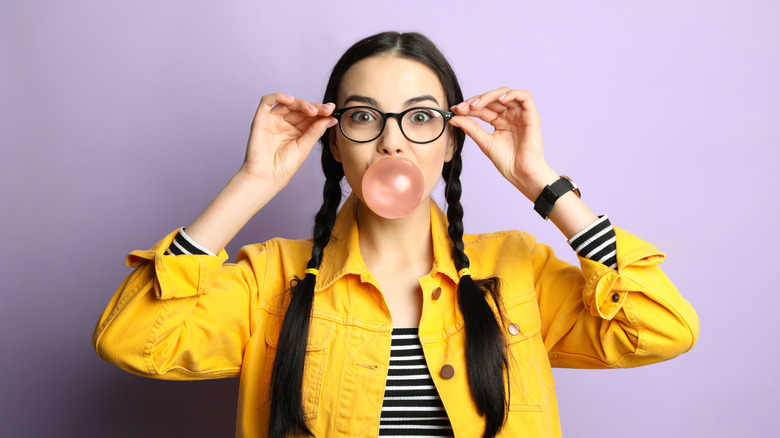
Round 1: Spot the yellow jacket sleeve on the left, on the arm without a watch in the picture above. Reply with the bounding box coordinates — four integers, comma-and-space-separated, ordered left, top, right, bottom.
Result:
92, 232, 266, 380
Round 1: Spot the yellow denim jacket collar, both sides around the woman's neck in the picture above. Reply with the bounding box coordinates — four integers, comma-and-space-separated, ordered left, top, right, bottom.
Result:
314, 194, 458, 292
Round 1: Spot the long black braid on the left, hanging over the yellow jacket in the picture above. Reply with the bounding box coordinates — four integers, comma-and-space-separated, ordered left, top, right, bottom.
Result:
269, 151, 344, 438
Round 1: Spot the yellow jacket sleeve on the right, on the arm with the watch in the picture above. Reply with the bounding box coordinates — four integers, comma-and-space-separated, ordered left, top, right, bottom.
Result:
532, 227, 699, 368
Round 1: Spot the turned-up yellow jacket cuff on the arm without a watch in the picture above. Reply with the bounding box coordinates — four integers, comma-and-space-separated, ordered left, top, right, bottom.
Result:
125, 230, 228, 300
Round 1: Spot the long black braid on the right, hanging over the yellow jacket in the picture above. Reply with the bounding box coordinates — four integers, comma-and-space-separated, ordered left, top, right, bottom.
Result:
442, 150, 508, 437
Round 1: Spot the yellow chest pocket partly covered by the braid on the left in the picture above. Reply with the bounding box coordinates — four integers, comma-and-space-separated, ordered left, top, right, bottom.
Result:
258, 314, 336, 420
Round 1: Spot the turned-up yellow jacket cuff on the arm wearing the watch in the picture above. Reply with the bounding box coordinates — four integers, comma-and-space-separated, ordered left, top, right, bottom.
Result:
580, 227, 666, 319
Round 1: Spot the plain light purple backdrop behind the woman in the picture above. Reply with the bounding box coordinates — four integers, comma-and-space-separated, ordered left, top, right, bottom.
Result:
0, 0, 780, 437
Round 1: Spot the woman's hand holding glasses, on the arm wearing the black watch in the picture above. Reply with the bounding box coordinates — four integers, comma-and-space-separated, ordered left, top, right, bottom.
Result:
450, 88, 558, 202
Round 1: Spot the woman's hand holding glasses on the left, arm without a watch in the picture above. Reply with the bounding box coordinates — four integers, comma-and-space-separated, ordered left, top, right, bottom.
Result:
239, 93, 337, 192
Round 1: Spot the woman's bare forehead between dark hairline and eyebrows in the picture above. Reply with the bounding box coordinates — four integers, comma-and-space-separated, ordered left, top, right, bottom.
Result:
336, 56, 448, 111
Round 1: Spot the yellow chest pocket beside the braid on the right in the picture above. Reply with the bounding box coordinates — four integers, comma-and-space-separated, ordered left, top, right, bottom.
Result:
504, 293, 555, 411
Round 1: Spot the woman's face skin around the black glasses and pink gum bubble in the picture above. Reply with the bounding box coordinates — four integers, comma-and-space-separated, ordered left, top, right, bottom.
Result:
330, 56, 455, 209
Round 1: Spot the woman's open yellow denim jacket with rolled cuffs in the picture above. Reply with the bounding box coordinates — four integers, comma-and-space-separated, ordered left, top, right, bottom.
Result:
93, 196, 699, 438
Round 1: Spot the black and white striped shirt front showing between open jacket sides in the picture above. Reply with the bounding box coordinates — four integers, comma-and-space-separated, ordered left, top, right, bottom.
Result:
379, 327, 453, 437
